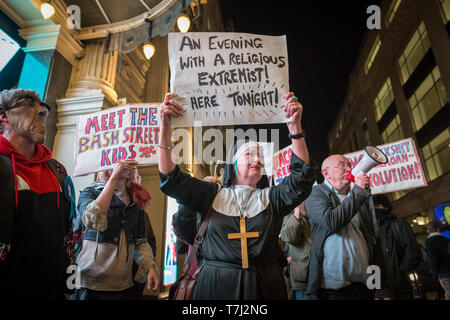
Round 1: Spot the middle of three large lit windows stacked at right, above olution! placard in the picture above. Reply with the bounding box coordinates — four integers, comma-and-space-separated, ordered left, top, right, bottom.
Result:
409, 66, 447, 131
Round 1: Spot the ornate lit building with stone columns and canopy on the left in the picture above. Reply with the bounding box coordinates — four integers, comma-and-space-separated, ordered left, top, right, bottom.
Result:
0, 0, 225, 294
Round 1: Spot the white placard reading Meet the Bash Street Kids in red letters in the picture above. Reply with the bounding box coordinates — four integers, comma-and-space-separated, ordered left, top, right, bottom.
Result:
73, 104, 159, 176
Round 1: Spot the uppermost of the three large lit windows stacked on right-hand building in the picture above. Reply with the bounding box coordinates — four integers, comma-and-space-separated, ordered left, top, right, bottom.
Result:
398, 22, 431, 84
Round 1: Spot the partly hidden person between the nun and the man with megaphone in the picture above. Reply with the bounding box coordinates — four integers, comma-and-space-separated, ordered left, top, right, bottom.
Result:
281, 202, 315, 300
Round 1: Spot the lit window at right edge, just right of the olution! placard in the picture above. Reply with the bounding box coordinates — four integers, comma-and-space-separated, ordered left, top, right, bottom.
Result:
422, 129, 450, 181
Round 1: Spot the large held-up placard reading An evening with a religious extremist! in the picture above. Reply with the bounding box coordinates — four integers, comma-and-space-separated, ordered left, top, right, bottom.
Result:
168, 32, 289, 127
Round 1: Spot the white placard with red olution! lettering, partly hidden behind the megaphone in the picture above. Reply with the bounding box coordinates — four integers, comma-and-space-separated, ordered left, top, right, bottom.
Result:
344, 138, 427, 194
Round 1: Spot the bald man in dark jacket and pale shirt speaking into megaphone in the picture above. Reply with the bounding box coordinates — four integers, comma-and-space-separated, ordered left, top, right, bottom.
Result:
305, 155, 391, 300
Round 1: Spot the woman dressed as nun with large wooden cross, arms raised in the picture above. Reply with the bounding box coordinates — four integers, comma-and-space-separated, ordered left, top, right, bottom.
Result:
159, 93, 319, 300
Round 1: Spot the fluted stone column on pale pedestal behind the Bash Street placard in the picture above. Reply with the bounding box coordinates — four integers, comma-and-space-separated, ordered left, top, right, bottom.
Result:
53, 39, 118, 197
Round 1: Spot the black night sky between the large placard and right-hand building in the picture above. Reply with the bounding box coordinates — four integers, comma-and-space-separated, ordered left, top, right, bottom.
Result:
221, 0, 380, 164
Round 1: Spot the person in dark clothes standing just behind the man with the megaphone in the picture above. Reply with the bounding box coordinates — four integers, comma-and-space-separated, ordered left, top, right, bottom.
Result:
373, 194, 422, 300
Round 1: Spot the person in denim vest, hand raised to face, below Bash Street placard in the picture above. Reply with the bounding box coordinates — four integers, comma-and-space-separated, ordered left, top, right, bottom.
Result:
78, 160, 159, 300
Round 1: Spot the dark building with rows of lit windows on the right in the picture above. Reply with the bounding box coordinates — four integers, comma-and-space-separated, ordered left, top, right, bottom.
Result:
328, 0, 450, 238
